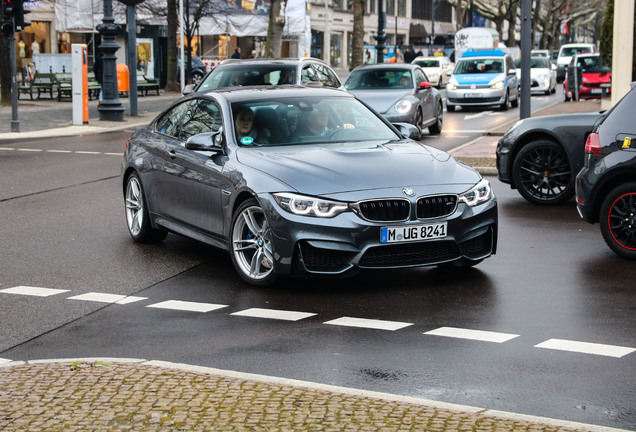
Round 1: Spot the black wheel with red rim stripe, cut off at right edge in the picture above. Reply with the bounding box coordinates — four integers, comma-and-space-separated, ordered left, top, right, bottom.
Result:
599, 182, 636, 260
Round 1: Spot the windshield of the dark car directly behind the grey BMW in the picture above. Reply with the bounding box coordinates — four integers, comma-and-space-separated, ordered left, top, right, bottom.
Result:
197, 63, 297, 91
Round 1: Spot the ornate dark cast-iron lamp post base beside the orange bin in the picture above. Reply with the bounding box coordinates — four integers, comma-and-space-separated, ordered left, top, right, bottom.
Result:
97, 0, 125, 121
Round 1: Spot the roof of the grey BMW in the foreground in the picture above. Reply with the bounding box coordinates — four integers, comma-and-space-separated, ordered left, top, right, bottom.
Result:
192, 85, 354, 103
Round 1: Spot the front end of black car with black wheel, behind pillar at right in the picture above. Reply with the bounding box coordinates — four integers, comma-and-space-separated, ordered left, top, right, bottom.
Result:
496, 112, 603, 205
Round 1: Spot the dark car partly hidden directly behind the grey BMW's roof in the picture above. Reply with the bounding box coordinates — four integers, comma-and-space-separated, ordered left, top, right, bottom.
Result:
183, 57, 344, 95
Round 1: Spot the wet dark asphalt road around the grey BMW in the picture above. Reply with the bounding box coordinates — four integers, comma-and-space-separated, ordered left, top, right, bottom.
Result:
0, 129, 636, 429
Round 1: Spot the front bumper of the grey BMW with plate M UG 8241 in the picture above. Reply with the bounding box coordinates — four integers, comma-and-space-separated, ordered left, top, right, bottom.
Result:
259, 194, 497, 274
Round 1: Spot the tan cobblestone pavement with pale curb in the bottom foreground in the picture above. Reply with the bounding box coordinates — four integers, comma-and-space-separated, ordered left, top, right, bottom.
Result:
0, 359, 628, 432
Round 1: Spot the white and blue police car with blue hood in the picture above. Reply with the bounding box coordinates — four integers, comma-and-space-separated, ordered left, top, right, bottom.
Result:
446, 50, 519, 112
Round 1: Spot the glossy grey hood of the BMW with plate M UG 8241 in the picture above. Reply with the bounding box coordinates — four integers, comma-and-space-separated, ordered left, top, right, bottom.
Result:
237, 140, 480, 196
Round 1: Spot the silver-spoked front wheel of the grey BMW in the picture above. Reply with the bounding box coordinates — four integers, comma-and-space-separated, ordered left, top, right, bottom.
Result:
230, 199, 277, 287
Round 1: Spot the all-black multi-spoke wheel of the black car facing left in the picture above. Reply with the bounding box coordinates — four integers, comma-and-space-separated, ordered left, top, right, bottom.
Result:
512, 140, 574, 205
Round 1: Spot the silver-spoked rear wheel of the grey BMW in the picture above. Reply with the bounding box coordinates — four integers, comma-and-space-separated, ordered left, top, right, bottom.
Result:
124, 173, 168, 243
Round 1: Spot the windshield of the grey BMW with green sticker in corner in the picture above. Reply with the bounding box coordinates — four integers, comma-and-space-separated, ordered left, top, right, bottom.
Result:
232, 96, 401, 147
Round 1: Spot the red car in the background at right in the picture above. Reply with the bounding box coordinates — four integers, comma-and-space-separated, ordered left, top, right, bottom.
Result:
563, 53, 612, 102
